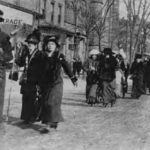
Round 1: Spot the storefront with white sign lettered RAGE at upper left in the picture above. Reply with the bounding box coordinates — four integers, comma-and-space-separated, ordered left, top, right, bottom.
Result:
0, 3, 34, 38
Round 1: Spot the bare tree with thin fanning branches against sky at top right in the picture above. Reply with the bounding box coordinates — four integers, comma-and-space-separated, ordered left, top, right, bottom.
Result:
123, 0, 150, 63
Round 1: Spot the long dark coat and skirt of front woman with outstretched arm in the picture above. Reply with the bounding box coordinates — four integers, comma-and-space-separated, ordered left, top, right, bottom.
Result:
41, 51, 73, 124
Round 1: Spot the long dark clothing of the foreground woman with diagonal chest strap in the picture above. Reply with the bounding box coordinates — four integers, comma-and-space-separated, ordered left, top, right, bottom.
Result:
16, 49, 44, 121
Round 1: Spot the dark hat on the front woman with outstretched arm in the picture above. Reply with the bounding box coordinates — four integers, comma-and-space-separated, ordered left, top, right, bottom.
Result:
44, 35, 60, 47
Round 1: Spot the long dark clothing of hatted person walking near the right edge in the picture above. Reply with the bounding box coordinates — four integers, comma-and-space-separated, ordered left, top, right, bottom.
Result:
130, 61, 145, 98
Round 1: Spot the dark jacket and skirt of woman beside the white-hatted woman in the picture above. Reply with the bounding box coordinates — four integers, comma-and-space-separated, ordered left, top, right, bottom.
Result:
98, 55, 117, 105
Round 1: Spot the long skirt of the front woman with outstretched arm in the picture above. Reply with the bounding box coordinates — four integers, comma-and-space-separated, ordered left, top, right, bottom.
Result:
41, 83, 64, 124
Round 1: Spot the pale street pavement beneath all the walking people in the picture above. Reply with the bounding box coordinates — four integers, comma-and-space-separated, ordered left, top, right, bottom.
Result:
0, 73, 150, 150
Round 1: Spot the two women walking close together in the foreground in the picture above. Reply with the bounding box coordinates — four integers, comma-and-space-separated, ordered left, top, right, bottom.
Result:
15, 30, 77, 133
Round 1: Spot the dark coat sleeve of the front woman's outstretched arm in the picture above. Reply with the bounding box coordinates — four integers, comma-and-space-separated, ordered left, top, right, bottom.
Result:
59, 54, 73, 78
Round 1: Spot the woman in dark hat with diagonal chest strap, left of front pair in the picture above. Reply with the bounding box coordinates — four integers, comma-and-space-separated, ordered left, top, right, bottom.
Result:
15, 29, 43, 124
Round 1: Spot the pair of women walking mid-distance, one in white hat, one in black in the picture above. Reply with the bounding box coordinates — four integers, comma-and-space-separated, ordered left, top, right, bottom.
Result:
84, 48, 117, 107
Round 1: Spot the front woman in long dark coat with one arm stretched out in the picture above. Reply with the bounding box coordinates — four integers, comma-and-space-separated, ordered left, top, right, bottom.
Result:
41, 36, 77, 133
